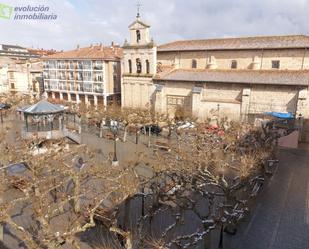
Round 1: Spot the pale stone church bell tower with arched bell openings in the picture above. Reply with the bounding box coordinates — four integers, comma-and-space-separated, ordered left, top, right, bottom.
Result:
121, 9, 157, 109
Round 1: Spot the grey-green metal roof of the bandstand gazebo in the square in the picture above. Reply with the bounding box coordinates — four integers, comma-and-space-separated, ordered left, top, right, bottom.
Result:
19, 100, 64, 115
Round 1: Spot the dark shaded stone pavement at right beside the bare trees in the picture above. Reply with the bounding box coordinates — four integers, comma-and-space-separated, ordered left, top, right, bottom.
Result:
223, 149, 309, 249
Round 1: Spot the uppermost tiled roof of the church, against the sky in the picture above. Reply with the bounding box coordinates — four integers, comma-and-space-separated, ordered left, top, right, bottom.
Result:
158, 35, 309, 52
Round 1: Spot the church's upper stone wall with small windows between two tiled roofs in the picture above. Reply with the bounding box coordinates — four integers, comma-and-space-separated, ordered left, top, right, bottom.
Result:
158, 49, 309, 70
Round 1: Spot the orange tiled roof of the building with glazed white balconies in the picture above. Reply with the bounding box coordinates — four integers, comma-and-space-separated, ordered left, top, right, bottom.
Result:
43, 45, 122, 60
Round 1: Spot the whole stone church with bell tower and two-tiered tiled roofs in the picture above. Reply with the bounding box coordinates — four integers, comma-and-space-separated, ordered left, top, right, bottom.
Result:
121, 14, 309, 140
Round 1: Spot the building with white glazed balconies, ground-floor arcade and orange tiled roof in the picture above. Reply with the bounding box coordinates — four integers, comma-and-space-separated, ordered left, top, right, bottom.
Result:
44, 44, 122, 106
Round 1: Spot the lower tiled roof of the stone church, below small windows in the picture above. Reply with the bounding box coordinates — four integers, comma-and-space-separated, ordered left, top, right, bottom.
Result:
154, 69, 309, 86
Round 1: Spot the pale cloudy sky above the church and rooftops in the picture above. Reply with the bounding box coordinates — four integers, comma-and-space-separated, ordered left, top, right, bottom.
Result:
0, 0, 309, 50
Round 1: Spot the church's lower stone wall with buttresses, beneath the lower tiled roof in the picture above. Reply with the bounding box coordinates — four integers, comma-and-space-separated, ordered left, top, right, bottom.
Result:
155, 82, 299, 120
